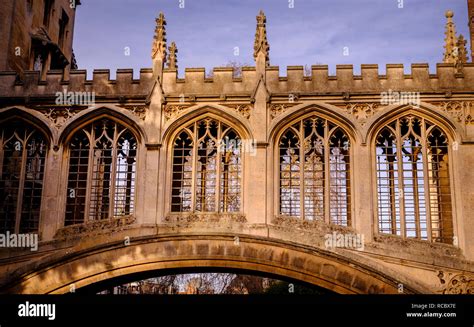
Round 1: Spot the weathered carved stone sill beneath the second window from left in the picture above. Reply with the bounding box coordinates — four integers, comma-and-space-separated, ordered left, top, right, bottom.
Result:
54, 216, 136, 239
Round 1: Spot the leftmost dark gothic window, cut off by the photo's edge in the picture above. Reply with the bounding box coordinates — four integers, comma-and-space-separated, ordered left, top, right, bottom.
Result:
0, 120, 47, 233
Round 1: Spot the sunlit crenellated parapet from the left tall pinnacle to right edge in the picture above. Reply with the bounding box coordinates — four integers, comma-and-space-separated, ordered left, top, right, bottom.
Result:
163, 64, 474, 94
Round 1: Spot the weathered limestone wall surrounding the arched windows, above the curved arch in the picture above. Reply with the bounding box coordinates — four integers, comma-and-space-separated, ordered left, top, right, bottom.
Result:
0, 58, 474, 293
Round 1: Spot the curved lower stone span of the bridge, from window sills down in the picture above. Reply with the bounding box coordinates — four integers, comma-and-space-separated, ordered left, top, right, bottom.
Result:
2, 216, 472, 294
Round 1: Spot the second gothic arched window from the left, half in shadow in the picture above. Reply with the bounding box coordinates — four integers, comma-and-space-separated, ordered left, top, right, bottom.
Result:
65, 119, 138, 225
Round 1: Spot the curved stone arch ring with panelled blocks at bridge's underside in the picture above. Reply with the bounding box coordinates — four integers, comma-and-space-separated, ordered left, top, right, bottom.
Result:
1, 235, 426, 294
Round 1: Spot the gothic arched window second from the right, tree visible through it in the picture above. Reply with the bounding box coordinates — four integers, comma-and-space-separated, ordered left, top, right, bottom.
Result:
279, 116, 351, 226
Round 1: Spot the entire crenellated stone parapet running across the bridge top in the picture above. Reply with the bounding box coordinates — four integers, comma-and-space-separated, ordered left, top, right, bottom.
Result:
0, 63, 474, 97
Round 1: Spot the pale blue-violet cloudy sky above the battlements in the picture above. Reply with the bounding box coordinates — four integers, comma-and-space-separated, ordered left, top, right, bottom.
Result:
74, 0, 470, 78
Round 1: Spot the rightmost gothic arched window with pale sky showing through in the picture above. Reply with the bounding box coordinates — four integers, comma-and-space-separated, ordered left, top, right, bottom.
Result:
376, 115, 453, 243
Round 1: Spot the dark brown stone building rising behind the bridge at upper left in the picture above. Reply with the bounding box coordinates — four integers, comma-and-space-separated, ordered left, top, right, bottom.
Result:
0, 0, 81, 80
